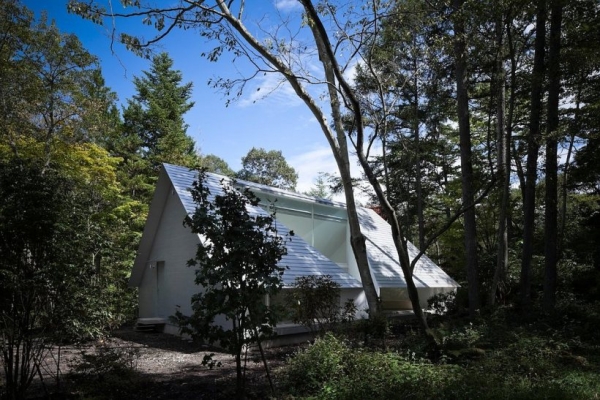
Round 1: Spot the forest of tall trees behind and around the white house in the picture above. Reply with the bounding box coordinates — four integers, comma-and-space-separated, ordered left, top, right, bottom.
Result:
0, 0, 600, 398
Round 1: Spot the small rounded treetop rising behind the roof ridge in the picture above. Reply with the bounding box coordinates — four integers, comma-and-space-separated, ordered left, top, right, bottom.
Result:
236, 147, 298, 190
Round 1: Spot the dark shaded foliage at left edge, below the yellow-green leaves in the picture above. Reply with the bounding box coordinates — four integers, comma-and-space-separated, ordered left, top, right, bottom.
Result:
0, 160, 126, 398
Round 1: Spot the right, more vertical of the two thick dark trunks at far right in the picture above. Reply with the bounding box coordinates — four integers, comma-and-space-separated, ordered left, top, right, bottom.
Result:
544, 0, 563, 312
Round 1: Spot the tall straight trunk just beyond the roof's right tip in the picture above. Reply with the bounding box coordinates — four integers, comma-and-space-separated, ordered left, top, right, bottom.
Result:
453, 0, 480, 315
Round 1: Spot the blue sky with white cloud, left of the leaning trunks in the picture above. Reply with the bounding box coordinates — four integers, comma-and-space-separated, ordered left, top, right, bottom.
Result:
23, 0, 336, 191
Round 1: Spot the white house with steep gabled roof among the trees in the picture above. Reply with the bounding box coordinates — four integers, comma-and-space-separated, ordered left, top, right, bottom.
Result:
129, 164, 458, 334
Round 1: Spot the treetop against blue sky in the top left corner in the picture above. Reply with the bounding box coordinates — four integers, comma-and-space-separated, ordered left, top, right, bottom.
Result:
0, 0, 109, 165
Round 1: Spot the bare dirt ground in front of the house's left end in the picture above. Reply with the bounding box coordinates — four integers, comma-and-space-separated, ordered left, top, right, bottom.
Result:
33, 328, 297, 399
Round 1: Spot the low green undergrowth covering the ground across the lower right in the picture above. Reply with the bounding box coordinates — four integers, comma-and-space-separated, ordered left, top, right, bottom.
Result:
279, 302, 600, 400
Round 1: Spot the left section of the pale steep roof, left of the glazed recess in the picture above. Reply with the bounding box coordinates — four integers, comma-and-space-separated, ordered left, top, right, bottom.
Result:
130, 164, 362, 288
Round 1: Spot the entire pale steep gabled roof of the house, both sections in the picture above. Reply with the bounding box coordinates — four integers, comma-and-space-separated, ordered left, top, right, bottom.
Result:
130, 164, 459, 288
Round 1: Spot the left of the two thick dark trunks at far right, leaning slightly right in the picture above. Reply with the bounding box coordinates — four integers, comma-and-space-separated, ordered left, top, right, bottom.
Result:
521, 0, 546, 313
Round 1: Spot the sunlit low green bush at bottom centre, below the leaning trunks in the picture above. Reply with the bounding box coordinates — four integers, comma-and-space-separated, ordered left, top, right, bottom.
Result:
283, 334, 456, 399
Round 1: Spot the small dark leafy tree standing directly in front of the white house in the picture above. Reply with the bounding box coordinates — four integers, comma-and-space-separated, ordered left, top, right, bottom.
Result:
176, 171, 286, 397
